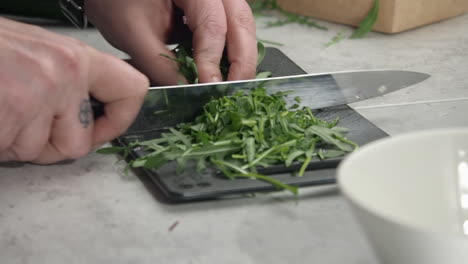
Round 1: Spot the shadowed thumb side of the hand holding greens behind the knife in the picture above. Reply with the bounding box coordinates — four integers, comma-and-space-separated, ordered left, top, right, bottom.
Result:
85, 0, 185, 85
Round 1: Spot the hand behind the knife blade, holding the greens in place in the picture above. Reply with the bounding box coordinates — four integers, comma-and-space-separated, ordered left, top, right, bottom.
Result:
85, 0, 257, 85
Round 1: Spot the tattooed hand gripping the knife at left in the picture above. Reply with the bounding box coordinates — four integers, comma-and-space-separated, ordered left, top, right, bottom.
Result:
0, 18, 149, 164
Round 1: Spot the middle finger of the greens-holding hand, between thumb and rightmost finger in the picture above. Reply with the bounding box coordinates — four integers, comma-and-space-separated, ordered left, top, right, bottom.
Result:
175, 0, 227, 82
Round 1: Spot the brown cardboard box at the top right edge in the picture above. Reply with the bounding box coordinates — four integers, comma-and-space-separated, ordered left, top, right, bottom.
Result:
277, 0, 468, 33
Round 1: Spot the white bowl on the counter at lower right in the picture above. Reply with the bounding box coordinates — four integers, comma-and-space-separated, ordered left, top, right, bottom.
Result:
338, 129, 468, 264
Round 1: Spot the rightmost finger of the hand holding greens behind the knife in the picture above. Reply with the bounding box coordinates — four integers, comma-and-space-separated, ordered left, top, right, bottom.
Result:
223, 0, 258, 81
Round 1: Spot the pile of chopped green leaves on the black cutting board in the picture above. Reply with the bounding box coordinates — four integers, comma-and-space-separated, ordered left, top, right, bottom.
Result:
98, 88, 357, 194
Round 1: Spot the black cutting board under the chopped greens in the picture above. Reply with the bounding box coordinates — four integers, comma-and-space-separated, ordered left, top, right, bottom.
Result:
116, 48, 387, 202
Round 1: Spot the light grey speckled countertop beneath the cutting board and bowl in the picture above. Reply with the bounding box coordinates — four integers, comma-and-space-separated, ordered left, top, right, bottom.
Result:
0, 15, 468, 264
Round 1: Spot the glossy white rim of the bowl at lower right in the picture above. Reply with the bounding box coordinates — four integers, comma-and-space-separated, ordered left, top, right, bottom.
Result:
336, 127, 468, 237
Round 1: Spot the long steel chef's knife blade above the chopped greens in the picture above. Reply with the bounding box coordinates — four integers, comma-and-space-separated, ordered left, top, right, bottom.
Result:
93, 70, 430, 116
